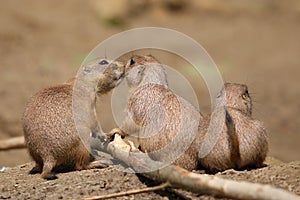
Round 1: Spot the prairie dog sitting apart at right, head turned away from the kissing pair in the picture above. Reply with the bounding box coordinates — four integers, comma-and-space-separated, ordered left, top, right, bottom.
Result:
195, 83, 268, 172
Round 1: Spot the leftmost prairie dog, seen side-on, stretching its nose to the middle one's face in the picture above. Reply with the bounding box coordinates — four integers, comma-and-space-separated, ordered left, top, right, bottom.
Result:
22, 59, 125, 179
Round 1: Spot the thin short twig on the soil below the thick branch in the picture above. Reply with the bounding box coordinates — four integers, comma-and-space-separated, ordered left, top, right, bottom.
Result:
83, 183, 170, 200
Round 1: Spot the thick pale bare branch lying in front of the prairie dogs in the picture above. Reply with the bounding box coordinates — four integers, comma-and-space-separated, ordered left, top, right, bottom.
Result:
107, 134, 300, 200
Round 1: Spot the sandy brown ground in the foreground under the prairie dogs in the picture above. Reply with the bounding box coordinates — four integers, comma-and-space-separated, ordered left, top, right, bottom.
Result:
0, 158, 300, 200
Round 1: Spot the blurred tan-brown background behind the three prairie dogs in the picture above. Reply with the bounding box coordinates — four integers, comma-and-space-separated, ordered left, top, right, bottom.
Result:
0, 0, 300, 167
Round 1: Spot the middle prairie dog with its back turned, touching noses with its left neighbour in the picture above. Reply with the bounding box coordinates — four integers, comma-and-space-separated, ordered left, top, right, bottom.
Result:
120, 55, 202, 170
